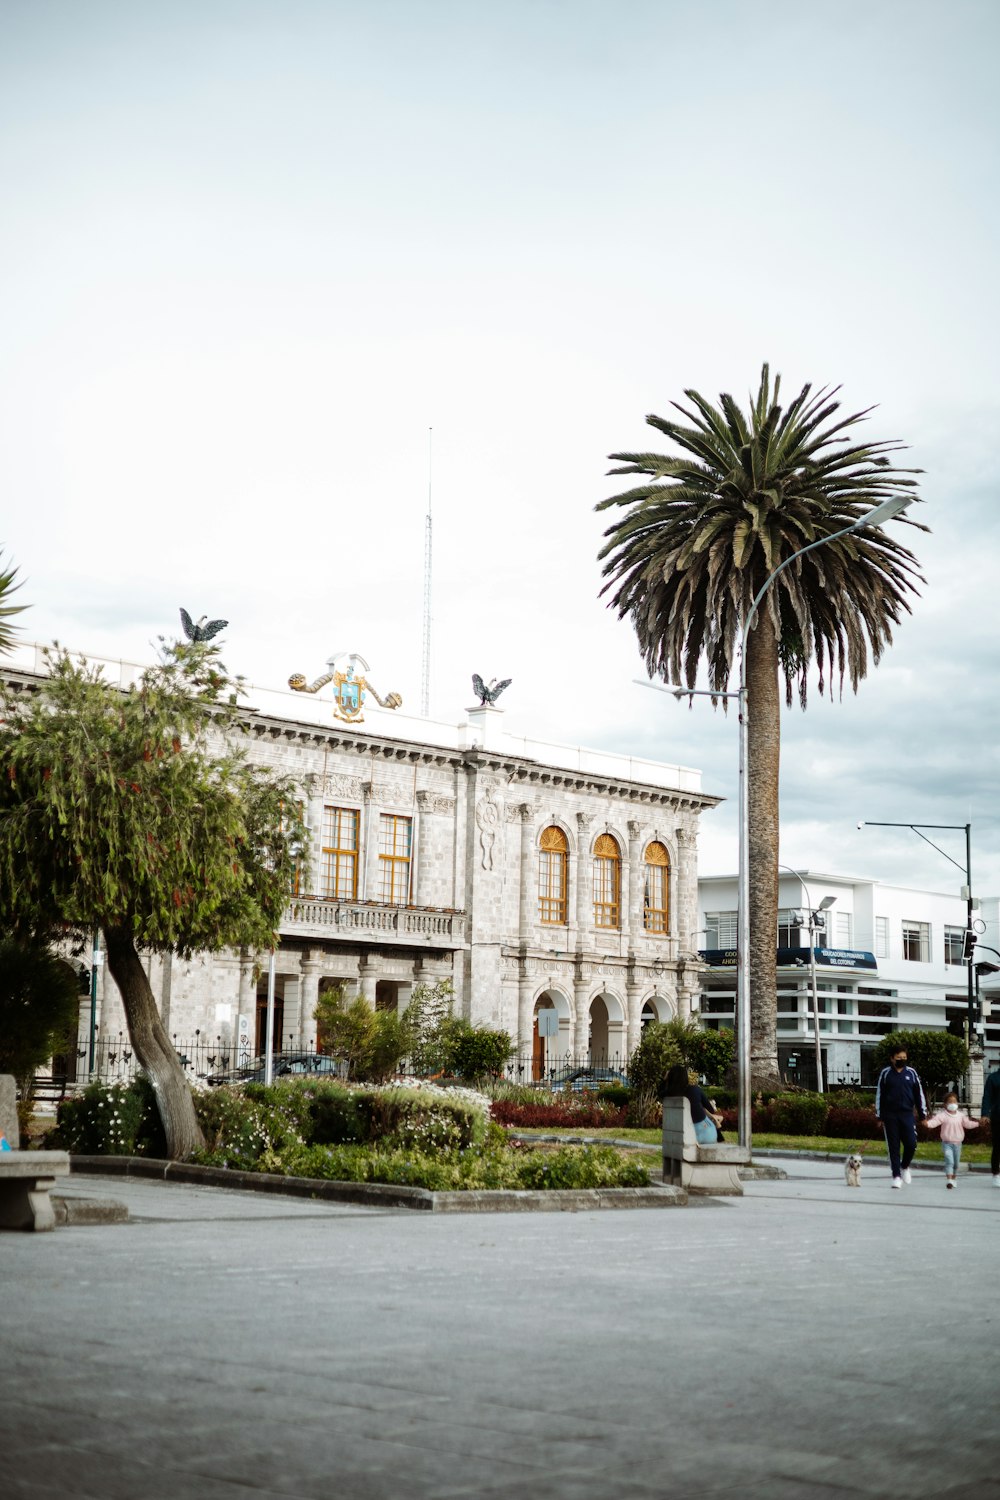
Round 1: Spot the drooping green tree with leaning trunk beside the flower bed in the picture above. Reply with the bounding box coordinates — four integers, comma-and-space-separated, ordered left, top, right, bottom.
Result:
0, 642, 304, 1158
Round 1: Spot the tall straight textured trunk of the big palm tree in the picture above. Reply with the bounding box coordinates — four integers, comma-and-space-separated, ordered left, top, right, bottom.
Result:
747, 608, 781, 1088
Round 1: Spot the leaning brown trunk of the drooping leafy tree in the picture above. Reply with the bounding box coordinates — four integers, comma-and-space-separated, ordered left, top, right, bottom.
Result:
103, 927, 205, 1161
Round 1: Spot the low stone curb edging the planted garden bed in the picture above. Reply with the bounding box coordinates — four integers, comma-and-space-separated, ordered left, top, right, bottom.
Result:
66, 1157, 688, 1223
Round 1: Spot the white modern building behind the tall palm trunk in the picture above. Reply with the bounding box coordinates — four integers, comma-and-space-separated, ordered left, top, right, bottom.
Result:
697, 869, 1000, 1086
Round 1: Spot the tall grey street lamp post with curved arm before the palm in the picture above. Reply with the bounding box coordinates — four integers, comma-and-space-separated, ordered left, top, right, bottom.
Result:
642, 495, 915, 1148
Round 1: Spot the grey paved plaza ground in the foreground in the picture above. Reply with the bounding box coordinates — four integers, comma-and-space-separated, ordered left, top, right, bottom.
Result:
0, 1163, 1000, 1500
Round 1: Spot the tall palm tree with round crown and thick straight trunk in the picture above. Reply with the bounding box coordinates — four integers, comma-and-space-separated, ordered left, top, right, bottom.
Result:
597, 365, 928, 1083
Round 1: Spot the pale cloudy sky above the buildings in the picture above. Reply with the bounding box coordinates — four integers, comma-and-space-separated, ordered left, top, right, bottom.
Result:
0, 0, 1000, 896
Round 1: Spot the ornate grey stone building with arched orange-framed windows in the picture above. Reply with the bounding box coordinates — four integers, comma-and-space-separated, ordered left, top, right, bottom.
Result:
4, 648, 718, 1076
